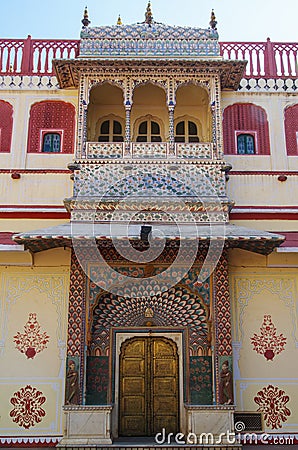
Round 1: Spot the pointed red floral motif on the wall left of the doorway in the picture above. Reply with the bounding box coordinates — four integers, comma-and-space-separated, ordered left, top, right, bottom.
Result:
14, 313, 50, 359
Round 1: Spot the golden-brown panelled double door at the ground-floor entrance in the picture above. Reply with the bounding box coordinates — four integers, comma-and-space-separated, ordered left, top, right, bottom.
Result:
119, 337, 179, 436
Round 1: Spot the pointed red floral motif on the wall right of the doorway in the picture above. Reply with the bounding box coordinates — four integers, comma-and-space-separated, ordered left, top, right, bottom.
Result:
251, 315, 287, 361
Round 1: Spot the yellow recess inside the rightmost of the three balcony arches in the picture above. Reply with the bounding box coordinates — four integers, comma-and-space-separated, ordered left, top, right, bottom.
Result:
174, 83, 212, 142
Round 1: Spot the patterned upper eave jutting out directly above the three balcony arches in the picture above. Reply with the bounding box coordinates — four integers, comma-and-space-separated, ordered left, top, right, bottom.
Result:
53, 58, 247, 91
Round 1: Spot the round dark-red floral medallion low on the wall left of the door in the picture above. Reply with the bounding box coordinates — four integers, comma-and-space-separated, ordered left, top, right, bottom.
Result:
9, 385, 46, 429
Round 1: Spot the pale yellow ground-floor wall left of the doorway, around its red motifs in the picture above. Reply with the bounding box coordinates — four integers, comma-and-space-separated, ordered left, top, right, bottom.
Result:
0, 249, 70, 437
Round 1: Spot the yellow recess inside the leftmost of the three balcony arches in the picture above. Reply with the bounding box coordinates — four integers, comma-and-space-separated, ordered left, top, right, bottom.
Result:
87, 82, 125, 142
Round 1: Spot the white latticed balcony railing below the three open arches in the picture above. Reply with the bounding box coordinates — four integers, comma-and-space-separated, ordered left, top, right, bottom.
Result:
86, 142, 213, 160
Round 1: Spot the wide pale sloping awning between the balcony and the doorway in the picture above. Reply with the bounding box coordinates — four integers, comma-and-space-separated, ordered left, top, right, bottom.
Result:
12, 222, 285, 255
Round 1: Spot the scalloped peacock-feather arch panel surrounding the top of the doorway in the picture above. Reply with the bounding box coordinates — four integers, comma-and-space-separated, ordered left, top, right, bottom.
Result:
89, 266, 211, 355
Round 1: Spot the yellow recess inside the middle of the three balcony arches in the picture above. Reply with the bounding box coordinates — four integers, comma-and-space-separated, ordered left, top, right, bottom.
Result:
131, 82, 169, 141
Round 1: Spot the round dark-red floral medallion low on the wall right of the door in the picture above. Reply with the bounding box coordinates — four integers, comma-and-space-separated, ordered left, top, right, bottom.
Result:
254, 384, 291, 430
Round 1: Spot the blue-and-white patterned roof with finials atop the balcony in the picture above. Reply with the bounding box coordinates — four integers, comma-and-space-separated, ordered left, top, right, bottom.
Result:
79, 1, 220, 60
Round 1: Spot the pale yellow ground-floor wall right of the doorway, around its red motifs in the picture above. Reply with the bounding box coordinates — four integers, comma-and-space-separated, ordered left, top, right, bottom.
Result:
229, 249, 298, 433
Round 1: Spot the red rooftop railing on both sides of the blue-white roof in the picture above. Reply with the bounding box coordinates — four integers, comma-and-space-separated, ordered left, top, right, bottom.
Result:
0, 36, 298, 78
